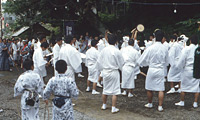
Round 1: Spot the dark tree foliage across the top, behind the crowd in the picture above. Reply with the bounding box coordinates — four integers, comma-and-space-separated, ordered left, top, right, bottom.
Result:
4, 0, 200, 36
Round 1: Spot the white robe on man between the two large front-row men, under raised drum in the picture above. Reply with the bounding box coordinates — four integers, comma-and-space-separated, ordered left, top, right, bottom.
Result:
121, 46, 140, 89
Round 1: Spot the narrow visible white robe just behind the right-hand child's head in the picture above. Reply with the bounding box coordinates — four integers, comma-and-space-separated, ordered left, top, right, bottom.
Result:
53, 43, 61, 76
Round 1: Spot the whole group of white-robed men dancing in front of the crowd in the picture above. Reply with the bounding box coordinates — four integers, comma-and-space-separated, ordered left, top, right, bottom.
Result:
16, 26, 199, 119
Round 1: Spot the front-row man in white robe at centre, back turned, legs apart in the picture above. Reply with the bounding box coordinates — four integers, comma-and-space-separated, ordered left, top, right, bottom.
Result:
97, 34, 124, 113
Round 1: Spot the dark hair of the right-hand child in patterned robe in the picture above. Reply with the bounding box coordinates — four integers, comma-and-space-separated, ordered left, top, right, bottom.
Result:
56, 60, 67, 73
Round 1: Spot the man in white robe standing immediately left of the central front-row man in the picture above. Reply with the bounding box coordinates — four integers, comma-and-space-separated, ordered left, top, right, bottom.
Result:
86, 40, 100, 94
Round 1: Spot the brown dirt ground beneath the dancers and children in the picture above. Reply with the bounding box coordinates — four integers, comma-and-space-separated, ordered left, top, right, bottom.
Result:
0, 67, 200, 120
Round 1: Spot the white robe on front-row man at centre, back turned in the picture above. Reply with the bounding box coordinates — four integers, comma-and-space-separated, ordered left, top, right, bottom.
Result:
97, 45, 124, 95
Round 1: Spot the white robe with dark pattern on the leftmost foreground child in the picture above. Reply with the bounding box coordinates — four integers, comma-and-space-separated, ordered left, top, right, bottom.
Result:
14, 70, 44, 120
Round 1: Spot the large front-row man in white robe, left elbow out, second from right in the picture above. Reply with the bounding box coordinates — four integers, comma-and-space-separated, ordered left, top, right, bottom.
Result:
137, 30, 168, 111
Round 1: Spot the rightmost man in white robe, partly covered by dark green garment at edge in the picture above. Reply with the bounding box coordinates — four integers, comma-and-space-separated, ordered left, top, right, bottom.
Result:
175, 35, 200, 108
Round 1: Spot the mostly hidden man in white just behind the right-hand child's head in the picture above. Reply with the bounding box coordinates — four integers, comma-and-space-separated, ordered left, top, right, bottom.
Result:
53, 37, 63, 76
